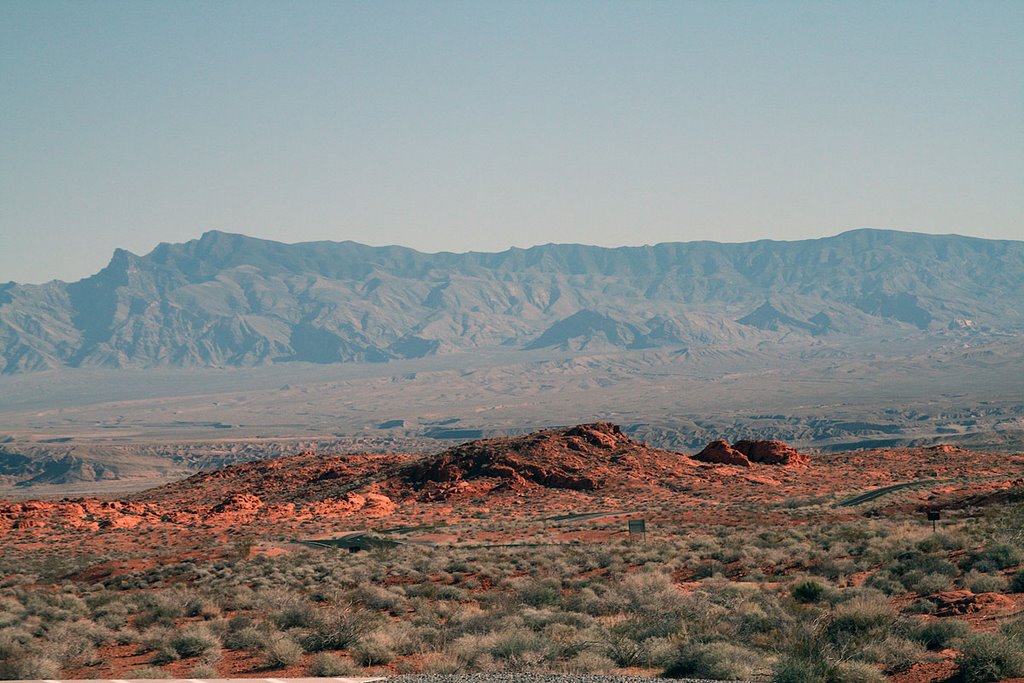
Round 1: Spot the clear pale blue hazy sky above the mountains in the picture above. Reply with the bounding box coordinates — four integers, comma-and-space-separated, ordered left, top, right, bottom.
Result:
0, 0, 1024, 282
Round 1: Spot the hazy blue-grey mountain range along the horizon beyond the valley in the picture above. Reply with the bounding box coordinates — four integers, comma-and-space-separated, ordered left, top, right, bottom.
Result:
0, 229, 1024, 374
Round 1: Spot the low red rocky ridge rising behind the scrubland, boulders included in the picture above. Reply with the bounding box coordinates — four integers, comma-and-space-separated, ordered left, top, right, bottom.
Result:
0, 422, 807, 530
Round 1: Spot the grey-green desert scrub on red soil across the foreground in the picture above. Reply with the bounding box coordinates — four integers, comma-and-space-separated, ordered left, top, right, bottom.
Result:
0, 438, 1024, 683
